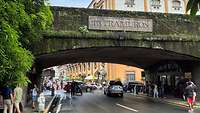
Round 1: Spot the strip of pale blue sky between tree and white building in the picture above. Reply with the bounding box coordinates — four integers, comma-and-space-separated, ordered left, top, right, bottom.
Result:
49, 0, 92, 8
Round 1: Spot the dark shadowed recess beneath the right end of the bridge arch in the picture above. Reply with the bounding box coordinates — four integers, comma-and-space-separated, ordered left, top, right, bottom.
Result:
150, 62, 188, 98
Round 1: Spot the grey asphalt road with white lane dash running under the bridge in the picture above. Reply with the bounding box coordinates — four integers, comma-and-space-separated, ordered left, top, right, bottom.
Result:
60, 90, 200, 113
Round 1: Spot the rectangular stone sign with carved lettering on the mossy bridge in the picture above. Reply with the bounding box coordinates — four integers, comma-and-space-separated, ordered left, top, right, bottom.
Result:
88, 16, 153, 32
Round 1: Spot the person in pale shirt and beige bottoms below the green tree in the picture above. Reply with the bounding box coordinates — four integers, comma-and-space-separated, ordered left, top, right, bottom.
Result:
14, 84, 23, 113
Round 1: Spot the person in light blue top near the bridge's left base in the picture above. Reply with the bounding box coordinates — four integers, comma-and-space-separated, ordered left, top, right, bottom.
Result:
31, 85, 38, 109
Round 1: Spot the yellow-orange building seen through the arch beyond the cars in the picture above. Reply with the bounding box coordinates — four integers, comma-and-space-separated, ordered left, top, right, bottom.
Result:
66, 62, 143, 82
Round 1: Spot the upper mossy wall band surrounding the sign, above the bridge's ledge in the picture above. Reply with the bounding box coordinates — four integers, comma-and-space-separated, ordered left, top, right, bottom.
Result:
52, 7, 200, 36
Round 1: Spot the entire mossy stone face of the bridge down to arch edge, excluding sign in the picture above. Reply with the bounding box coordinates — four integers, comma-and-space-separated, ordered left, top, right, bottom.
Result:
33, 7, 200, 61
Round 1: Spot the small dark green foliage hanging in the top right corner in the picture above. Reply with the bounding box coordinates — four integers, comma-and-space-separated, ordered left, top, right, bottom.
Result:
186, 0, 200, 16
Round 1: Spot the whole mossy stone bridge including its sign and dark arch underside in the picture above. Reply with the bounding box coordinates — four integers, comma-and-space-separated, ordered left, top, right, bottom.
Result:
30, 7, 200, 98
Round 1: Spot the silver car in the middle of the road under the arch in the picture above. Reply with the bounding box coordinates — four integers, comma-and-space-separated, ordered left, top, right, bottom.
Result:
104, 81, 123, 97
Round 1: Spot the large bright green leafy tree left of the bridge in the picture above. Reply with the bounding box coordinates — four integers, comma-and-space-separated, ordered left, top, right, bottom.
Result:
0, 0, 52, 85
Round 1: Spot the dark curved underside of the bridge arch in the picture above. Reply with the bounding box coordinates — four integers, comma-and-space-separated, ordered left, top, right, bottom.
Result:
36, 47, 200, 69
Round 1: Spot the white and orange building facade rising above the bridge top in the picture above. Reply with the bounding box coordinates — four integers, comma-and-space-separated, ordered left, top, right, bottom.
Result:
88, 0, 200, 15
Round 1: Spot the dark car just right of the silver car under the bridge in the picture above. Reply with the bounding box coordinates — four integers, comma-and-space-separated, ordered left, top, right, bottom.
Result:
123, 81, 144, 94
